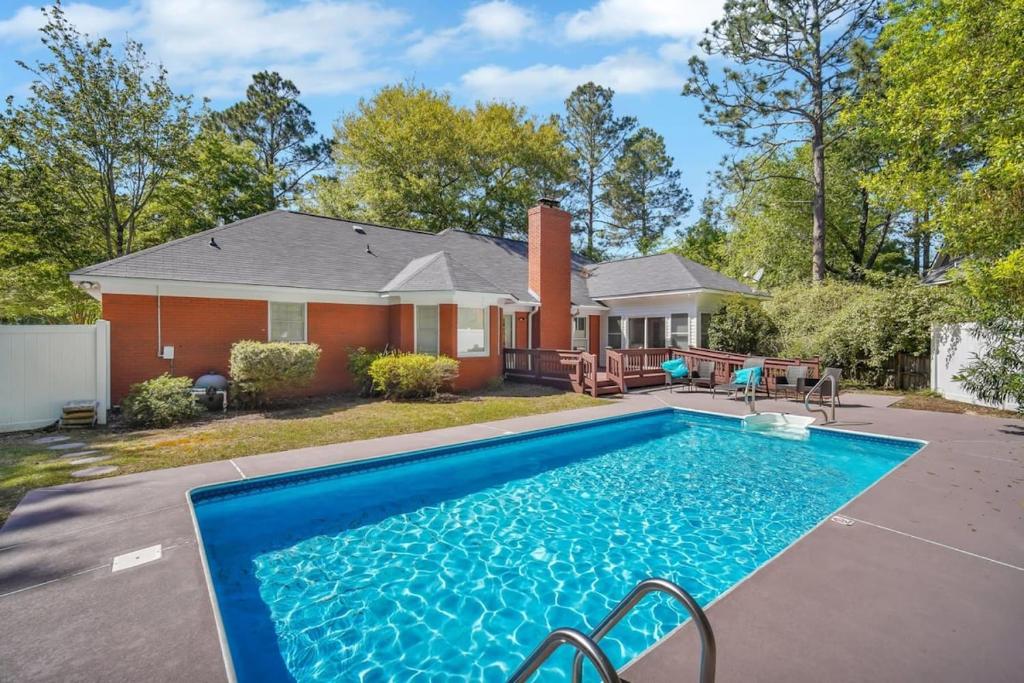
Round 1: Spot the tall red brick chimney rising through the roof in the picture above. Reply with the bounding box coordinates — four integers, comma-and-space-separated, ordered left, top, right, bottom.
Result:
528, 199, 572, 348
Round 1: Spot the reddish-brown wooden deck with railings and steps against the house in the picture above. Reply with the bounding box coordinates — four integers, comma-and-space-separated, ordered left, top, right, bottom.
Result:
503, 346, 819, 396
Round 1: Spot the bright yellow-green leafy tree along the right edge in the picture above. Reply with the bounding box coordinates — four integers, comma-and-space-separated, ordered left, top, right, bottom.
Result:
856, 0, 1024, 409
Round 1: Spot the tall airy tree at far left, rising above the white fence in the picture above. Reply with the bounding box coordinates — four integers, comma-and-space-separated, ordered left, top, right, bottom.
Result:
0, 4, 195, 258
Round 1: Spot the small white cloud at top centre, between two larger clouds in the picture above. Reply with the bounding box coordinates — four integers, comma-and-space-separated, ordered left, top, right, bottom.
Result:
406, 0, 536, 62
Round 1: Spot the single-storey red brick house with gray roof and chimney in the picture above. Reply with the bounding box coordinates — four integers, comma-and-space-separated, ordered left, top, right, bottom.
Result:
71, 202, 753, 403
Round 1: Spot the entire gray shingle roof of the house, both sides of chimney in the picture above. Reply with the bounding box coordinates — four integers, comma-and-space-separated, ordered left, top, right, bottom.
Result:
72, 211, 751, 305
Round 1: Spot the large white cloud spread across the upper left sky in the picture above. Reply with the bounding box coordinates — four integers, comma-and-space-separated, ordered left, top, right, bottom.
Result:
0, 0, 408, 97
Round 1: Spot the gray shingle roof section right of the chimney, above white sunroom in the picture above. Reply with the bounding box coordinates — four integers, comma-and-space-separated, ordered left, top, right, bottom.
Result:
587, 254, 754, 299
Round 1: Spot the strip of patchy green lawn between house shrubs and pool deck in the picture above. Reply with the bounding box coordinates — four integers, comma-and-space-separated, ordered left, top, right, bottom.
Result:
0, 383, 608, 523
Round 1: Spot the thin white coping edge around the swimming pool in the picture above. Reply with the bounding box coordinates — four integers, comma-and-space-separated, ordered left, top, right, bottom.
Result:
184, 401, 929, 683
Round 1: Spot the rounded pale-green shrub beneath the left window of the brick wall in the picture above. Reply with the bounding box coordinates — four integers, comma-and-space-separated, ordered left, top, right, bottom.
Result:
230, 341, 321, 405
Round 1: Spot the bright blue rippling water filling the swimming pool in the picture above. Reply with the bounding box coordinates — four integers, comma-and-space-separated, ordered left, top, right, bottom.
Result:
191, 410, 921, 682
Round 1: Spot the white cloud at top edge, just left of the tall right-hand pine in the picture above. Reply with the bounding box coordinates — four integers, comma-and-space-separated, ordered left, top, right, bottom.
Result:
565, 0, 722, 40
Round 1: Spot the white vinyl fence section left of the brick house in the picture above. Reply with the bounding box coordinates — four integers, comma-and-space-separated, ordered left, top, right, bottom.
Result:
0, 321, 111, 432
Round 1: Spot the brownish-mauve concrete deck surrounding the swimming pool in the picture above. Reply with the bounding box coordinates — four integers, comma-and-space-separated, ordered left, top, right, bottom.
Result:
0, 390, 1024, 683
